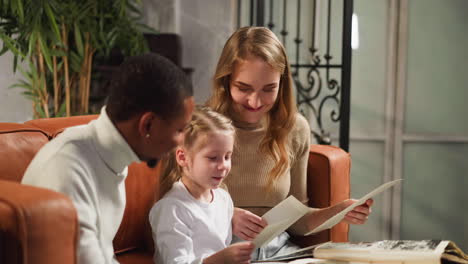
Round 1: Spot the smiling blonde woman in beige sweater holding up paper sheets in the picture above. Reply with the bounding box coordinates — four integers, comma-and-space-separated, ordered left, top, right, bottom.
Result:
207, 27, 373, 259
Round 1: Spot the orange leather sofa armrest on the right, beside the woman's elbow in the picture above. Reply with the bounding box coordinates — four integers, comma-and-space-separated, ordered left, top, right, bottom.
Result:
295, 145, 351, 246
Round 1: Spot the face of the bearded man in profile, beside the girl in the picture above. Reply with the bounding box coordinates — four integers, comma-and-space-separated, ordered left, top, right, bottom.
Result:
143, 97, 195, 160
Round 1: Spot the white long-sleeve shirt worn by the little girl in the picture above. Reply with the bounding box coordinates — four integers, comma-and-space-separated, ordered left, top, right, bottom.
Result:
149, 181, 234, 264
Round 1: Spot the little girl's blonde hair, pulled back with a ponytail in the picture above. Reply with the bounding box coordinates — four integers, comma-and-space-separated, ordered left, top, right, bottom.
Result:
160, 106, 235, 197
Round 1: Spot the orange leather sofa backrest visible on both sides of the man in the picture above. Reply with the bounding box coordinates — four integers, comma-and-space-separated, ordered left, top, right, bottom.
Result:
0, 115, 159, 253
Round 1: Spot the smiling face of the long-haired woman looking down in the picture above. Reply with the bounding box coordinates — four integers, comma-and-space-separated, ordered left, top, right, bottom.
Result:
230, 56, 281, 123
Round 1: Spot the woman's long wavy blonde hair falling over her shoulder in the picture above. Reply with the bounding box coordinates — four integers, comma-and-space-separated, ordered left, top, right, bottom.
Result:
207, 27, 297, 189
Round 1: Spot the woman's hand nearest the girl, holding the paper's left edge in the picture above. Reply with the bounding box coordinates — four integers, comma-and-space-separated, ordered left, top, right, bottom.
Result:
232, 207, 267, 241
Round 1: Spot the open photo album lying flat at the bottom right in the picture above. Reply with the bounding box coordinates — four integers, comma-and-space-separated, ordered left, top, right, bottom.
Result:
253, 240, 468, 264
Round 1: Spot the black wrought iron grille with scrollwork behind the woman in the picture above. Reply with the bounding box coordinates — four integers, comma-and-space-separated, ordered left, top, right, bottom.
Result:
237, 0, 353, 151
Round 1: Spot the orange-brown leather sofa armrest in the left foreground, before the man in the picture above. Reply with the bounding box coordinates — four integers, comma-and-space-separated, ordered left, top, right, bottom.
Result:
0, 180, 78, 264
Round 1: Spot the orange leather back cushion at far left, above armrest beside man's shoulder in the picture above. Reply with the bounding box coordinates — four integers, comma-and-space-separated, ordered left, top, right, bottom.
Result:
0, 123, 49, 182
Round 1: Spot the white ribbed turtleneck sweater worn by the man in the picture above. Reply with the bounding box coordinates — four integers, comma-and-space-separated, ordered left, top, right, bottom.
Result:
22, 108, 139, 264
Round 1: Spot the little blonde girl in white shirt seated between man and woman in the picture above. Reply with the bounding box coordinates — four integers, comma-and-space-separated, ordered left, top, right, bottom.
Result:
149, 107, 254, 264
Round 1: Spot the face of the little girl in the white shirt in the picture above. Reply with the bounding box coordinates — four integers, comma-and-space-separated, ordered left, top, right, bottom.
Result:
176, 132, 234, 198
